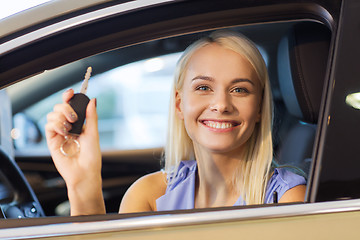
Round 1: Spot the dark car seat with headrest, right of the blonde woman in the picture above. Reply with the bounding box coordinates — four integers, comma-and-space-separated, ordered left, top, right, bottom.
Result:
275, 22, 331, 174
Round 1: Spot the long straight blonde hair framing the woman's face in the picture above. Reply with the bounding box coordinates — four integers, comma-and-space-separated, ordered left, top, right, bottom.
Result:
165, 31, 273, 204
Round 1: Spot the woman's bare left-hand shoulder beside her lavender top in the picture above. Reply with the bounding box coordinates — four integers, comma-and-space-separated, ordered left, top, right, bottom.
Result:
119, 171, 167, 213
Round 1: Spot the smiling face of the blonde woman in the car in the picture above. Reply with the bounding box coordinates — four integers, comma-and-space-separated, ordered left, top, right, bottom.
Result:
176, 43, 262, 153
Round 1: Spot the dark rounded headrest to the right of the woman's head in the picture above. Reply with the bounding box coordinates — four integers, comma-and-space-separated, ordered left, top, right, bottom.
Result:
278, 22, 331, 123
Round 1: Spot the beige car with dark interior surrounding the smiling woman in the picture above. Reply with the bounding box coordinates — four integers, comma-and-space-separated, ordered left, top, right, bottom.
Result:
0, 0, 360, 239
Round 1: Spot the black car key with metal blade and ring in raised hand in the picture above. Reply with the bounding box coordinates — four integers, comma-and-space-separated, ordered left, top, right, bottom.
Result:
60, 67, 92, 157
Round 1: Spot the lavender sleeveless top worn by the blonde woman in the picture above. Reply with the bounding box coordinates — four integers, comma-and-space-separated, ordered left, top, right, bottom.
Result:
156, 160, 306, 211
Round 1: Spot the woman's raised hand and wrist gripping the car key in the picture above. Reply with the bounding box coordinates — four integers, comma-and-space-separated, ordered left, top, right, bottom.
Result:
45, 89, 105, 215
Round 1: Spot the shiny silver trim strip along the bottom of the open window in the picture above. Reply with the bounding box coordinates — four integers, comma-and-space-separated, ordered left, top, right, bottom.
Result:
0, 199, 360, 238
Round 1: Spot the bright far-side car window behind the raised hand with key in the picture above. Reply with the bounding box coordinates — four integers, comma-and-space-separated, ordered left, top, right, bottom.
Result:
10, 53, 181, 151
